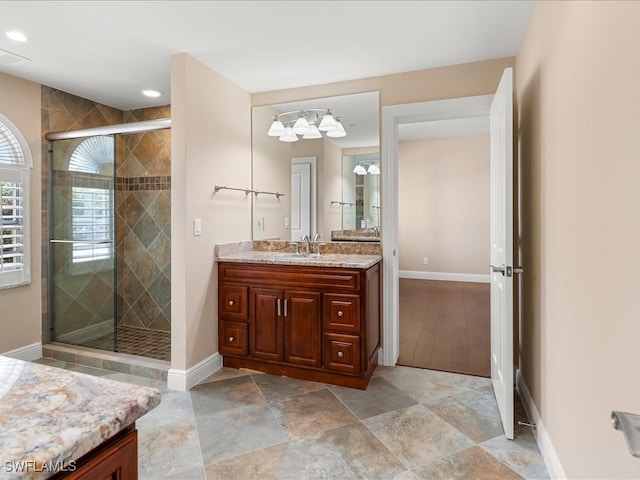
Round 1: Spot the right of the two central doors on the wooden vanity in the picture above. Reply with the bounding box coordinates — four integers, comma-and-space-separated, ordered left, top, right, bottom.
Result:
283, 291, 322, 367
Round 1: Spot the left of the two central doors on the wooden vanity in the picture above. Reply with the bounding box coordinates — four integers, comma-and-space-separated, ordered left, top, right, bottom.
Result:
249, 288, 284, 362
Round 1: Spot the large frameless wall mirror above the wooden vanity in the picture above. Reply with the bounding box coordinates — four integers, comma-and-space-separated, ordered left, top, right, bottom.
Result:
252, 92, 381, 242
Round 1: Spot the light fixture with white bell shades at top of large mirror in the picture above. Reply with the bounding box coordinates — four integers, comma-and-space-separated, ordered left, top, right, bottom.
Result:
267, 108, 347, 142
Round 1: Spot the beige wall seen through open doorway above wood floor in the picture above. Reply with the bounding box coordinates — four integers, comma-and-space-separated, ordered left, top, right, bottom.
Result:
398, 135, 489, 275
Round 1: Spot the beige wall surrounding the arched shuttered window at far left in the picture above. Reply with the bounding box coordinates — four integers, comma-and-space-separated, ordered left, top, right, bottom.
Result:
0, 73, 43, 352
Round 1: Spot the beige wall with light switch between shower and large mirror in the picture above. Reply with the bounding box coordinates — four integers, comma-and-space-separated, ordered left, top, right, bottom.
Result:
171, 54, 251, 369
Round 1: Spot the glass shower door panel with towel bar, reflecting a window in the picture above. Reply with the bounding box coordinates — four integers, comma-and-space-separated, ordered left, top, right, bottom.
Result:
48, 135, 116, 351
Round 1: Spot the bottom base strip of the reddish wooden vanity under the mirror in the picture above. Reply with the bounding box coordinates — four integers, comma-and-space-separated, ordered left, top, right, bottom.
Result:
223, 354, 378, 390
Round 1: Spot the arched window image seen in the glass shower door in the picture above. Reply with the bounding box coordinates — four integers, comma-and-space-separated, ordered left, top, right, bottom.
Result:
69, 136, 115, 263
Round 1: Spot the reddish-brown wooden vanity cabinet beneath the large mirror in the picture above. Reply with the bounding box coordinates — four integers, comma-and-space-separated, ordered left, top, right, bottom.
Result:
218, 262, 380, 389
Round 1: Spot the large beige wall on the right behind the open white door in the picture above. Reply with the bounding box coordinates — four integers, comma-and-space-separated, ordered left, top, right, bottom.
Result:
516, 2, 640, 479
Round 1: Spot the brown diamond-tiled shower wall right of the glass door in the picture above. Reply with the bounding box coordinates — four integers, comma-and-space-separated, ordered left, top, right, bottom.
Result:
116, 107, 171, 331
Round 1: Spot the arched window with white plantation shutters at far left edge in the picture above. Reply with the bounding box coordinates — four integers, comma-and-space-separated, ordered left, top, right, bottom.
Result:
0, 114, 33, 288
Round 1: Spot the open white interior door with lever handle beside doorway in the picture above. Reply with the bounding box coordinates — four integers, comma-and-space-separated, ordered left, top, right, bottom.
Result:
490, 68, 513, 439
